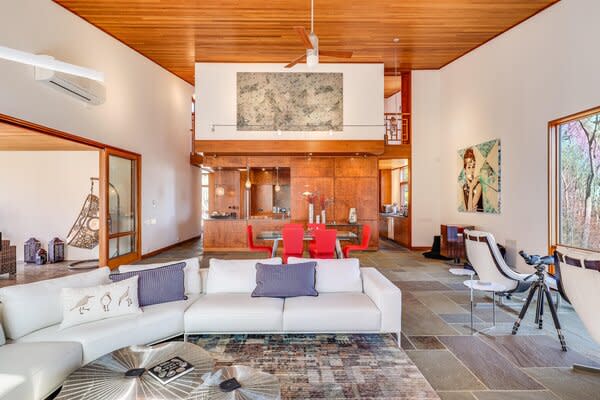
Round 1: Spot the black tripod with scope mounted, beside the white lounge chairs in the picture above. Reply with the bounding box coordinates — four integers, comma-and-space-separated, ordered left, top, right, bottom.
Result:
512, 251, 567, 351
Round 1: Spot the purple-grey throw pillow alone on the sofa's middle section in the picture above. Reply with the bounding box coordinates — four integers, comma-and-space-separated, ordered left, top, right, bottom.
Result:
252, 261, 319, 298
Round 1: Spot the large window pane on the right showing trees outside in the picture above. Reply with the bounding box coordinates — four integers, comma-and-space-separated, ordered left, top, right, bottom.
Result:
558, 114, 600, 249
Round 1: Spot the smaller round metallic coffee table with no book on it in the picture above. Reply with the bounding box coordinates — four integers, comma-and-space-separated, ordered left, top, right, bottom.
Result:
189, 365, 281, 400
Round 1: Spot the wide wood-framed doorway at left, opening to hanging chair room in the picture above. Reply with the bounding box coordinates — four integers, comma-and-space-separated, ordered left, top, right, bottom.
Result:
0, 114, 141, 268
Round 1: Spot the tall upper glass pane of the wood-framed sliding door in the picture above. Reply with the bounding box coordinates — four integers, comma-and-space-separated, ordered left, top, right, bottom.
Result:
108, 155, 137, 233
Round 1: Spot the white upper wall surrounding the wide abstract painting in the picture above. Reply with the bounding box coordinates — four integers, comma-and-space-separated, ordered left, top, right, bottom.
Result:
196, 63, 385, 140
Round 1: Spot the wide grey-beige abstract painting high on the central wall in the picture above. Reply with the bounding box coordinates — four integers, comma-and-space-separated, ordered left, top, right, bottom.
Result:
237, 72, 344, 131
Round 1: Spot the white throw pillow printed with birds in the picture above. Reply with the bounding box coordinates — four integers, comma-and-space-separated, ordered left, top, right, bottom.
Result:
59, 276, 142, 329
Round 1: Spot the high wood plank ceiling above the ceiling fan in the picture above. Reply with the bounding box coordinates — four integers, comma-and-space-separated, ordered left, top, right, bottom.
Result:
55, 0, 558, 84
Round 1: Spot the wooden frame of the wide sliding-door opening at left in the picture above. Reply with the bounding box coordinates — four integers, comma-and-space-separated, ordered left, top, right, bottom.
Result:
0, 113, 142, 267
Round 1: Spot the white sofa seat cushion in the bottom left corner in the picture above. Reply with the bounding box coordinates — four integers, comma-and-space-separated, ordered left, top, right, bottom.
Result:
0, 342, 82, 400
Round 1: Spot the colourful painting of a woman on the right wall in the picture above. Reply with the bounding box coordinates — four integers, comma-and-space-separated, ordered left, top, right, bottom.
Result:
457, 139, 501, 214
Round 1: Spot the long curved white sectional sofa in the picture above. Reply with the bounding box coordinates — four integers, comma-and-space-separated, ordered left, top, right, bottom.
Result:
0, 258, 401, 400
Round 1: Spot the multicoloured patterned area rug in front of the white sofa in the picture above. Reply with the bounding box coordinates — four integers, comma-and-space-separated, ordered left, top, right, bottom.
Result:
180, 335, 439, 400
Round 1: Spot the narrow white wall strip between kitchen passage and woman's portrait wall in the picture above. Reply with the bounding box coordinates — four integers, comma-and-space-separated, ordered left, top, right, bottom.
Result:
410, 71, 442, 247
